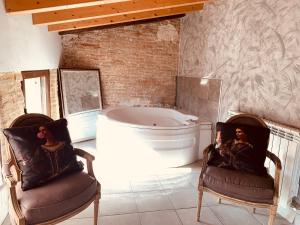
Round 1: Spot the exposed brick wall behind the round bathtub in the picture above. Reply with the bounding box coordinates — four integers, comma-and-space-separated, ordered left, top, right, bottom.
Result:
61, 19, 180, 107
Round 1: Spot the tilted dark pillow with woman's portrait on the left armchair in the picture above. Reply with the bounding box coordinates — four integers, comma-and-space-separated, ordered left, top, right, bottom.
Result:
3, 119, 83, 191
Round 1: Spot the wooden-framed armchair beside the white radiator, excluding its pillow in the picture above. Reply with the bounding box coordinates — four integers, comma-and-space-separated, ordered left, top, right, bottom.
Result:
197, 114, 281, 225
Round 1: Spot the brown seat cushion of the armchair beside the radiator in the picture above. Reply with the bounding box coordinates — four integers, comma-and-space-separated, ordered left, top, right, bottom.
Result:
203, 166, 274, 204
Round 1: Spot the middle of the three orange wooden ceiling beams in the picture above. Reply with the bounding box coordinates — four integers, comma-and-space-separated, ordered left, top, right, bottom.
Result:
32, 0, 208, 25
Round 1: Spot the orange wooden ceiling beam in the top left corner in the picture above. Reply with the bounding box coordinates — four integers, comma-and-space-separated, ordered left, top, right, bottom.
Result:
4, 0, 129, 14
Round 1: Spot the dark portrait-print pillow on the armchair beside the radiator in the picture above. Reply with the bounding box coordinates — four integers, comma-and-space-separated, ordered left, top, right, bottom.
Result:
209, 122, 270, 175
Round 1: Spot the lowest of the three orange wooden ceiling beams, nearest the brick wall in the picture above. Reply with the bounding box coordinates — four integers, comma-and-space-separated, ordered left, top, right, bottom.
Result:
48, 3, 203, 31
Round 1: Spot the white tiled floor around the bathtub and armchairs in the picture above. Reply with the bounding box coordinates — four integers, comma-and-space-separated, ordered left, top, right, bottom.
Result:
2, 142, 290, 225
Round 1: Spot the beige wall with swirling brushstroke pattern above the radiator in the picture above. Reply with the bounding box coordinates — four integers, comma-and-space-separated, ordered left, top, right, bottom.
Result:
179, 0, 300, 127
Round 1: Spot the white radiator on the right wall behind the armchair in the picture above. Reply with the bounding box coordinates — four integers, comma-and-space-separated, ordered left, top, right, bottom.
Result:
229, 111, 300, 222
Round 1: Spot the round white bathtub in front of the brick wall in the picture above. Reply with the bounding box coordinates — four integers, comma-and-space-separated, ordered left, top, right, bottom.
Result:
96, 107, 210, 176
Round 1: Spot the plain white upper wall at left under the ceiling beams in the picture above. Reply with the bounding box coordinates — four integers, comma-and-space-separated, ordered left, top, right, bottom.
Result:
0, 1, 61, 72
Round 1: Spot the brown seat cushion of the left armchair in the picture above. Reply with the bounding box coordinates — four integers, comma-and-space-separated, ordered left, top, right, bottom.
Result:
17, 172, 97, 225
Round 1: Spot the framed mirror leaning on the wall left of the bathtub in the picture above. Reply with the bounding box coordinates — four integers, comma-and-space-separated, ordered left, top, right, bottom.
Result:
58, 68, 102, 142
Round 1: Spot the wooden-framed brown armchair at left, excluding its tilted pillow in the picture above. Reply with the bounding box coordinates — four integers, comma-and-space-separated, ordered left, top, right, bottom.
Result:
3, 114, 101, 225
